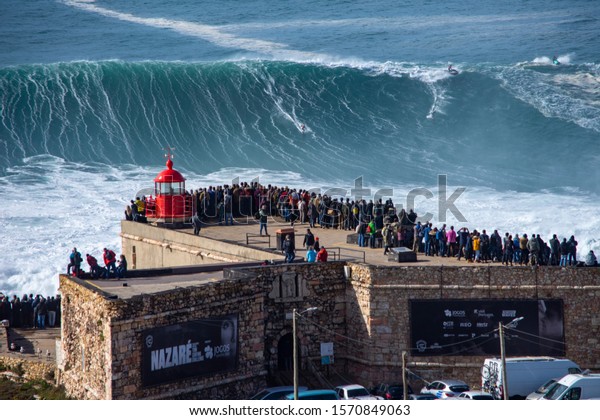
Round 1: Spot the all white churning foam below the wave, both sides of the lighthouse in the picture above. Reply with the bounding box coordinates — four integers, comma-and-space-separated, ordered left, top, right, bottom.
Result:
0, 156, 600, 295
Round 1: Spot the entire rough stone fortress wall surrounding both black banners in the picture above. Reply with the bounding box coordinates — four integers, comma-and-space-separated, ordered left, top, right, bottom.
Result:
59, 254, 600, 399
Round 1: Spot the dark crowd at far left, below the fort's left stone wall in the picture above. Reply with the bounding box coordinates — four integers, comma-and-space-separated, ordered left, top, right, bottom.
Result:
0, 293, 61, 330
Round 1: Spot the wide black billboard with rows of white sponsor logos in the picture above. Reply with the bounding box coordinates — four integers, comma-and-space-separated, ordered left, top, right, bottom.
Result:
410, 299, 565, 356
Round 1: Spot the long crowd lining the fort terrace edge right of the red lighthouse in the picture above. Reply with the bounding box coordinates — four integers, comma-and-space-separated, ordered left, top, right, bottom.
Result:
120, 182, 597, 266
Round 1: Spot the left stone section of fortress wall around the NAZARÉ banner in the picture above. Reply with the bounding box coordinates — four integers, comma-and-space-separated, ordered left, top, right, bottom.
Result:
58, 275, 265, 399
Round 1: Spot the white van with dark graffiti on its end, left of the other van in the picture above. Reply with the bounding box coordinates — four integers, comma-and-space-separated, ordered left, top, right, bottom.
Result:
481, 357, 581, 399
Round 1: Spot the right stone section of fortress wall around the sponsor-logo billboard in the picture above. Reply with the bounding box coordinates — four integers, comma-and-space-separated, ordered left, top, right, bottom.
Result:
346, 264, 600, 388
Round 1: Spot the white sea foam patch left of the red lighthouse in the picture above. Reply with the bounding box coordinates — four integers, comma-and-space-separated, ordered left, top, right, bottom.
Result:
0, 156, 152, 295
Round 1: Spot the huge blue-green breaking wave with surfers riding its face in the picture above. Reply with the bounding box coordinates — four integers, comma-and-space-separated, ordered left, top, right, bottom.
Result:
0, 60, 600, 192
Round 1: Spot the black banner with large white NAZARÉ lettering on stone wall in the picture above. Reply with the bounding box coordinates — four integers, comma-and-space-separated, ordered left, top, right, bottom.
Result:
142, 314, 238, 386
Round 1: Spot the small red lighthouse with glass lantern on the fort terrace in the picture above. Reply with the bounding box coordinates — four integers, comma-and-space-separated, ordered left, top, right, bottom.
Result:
146, 153, 192, 225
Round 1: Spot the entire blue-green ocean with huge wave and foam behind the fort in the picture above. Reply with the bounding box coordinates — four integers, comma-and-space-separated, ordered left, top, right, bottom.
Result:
0, 0, 600, 295
